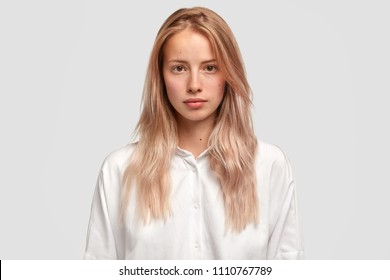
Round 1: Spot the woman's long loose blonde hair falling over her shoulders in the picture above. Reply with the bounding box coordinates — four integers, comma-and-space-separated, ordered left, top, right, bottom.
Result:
121, 7, 259, 231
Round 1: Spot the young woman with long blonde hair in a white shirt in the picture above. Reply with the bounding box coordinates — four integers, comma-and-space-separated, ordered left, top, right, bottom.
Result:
84, 8, 303, 259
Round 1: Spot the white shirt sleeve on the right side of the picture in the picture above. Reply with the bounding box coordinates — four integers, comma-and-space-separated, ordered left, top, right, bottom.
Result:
267, 150, 303, 259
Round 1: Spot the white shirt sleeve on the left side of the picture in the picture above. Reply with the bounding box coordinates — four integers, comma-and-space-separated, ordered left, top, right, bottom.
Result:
84, 168, 122, 259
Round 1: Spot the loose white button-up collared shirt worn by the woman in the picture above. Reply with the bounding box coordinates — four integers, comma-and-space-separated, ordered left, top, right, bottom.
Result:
84, 141, 303, 260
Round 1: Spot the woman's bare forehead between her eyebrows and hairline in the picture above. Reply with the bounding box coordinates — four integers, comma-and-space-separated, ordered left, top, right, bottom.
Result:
163, 29, 215, 60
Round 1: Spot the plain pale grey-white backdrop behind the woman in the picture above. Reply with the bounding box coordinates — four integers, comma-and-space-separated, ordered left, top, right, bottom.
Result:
0, 0, 390, 259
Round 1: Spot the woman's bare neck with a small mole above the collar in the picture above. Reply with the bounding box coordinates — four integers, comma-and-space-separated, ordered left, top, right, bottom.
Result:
177, 115, 214, 158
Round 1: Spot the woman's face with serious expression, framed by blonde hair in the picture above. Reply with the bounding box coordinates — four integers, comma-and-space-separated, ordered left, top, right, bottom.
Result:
163, 29, 225, 125
